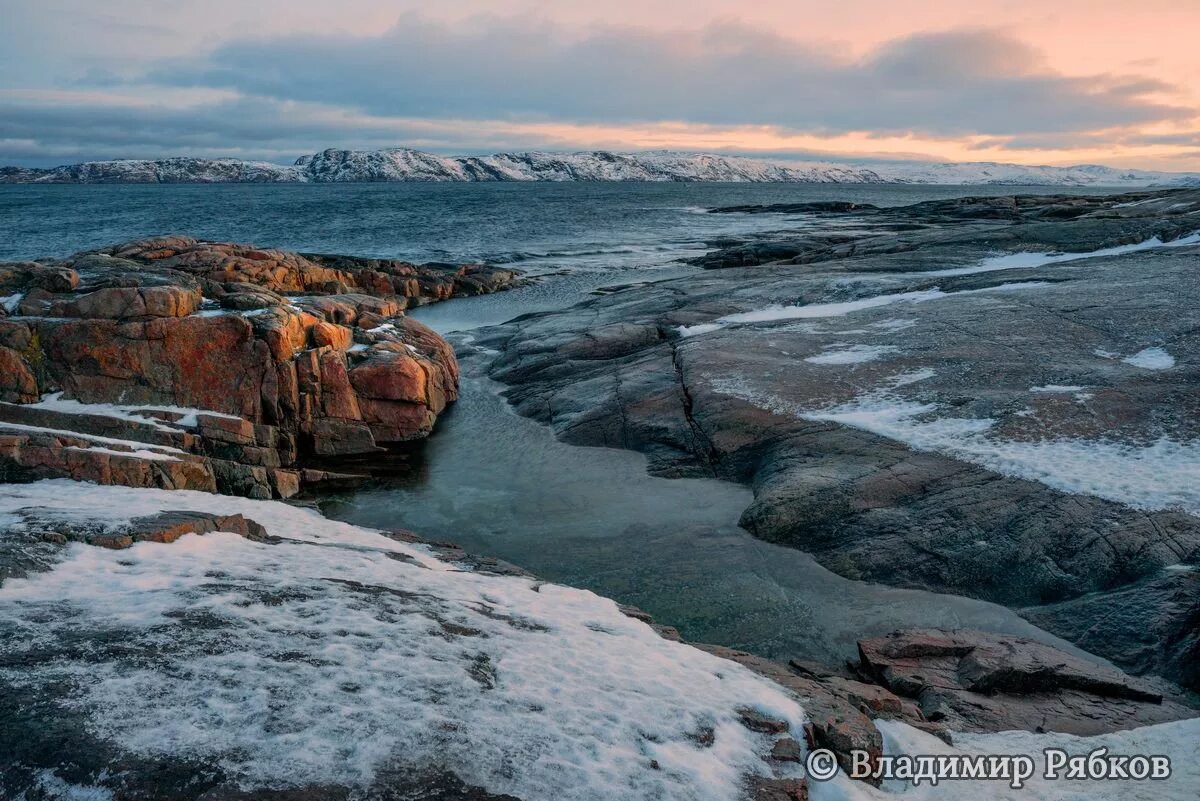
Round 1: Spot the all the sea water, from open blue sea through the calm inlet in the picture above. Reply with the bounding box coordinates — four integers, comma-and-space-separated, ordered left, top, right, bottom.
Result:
0, 183, 1104, 662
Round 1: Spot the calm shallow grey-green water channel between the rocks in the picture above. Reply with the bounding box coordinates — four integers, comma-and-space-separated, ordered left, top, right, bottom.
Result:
323, 290, 1089, 663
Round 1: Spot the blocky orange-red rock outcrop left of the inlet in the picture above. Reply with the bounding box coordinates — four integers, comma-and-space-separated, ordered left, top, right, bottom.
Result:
0, 237, 515, 498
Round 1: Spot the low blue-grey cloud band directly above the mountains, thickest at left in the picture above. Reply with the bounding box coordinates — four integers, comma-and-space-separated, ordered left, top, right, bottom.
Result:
7, 90, 883, 167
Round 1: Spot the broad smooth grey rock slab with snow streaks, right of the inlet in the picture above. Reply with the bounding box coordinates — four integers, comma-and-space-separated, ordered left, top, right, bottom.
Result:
479, 185, 1200, 688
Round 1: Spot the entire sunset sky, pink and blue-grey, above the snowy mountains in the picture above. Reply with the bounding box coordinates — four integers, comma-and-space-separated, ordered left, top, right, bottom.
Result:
0, 0, 1200, 171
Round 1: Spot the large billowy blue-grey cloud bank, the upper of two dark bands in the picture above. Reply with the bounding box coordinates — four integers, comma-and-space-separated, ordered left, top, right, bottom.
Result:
136, 13, 1195, 137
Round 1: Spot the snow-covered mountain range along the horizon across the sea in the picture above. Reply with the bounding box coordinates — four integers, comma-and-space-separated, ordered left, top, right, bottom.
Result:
0, 147, 1200, 187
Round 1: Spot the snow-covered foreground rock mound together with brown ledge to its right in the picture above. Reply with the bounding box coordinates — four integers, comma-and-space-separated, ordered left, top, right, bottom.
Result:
0, 481, 1194, 801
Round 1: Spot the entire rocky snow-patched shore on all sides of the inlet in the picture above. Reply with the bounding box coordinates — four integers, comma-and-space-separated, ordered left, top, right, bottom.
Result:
0, 192, 1200, 801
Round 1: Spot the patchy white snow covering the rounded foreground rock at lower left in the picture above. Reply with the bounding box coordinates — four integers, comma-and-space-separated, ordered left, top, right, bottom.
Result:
0, 481, 804, 800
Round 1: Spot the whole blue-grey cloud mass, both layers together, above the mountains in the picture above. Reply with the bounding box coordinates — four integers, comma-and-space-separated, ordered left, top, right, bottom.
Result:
0, 13, 1200, 168
